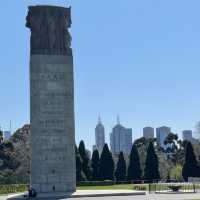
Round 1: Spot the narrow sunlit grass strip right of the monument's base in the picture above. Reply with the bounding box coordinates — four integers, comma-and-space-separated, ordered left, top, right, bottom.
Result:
77, 184, 148, 190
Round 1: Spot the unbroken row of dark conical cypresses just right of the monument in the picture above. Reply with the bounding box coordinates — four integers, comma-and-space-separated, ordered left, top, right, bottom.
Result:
76, 141, 160, 182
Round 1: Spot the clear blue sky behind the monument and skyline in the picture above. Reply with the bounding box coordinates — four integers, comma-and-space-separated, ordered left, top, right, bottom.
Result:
0, 0, 200, 148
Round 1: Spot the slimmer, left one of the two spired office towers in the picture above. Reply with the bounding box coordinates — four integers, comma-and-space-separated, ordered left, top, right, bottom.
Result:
95, 117, 105, 152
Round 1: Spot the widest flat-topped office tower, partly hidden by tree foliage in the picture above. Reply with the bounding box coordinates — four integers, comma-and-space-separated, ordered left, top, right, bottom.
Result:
156, 126, 171, 149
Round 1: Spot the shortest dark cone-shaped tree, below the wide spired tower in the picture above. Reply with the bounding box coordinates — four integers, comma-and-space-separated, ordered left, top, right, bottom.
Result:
115, 152, 126, 181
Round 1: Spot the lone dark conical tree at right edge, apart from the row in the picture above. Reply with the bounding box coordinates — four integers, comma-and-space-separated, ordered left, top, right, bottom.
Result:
182, 142, 200, 181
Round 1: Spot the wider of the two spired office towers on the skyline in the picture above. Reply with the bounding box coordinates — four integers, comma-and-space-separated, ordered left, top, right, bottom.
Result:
110, 119, 132, 154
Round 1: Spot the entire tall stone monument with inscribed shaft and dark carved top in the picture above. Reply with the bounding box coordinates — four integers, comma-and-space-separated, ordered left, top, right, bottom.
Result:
26, 6, 76, 196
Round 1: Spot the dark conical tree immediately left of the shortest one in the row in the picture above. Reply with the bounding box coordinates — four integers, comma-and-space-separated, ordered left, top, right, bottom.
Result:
99, 144, 115, 180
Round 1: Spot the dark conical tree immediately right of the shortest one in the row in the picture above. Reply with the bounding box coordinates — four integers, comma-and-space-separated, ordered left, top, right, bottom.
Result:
127, 144, 142, 181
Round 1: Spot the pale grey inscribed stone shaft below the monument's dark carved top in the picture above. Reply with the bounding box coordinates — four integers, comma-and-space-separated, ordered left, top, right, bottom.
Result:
30, 55, 76, 192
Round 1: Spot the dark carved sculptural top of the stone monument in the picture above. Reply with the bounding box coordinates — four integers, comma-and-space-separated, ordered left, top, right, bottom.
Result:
26, 6, 72, 55
